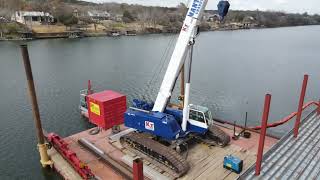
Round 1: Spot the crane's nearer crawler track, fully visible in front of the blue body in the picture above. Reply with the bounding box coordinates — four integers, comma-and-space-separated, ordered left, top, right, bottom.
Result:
120, 132, 189, 178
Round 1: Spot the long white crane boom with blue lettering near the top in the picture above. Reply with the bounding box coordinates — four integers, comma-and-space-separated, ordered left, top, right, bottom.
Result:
152, 0, 208, 112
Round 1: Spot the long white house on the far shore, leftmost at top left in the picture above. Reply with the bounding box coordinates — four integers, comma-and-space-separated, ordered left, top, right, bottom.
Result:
11, 11, 54, 24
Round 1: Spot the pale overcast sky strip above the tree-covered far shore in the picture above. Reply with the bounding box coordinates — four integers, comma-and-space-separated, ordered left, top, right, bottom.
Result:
86, 0, 320, 14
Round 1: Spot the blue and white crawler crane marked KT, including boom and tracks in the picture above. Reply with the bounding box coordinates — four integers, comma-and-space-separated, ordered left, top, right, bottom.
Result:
120, 0, 230, 177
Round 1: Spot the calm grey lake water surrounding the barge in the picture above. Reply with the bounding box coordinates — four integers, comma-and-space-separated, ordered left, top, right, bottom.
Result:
0, 26, 320, 179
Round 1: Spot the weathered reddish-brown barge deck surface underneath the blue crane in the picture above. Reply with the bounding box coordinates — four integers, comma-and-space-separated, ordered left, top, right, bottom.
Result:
49, 122, 278, 180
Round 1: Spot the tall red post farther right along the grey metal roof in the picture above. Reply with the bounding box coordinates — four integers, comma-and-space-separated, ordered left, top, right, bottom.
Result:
294, 75, 309, 138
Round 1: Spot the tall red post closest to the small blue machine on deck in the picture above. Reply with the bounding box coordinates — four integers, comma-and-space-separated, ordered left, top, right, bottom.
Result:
255, 94, 271, 176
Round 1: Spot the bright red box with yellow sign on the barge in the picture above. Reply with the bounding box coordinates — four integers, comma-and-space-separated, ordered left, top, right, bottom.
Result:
87, 90, 127, 129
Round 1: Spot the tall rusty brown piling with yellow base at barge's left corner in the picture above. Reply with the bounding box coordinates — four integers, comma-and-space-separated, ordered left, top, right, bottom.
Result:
20, 45, 53, 167
